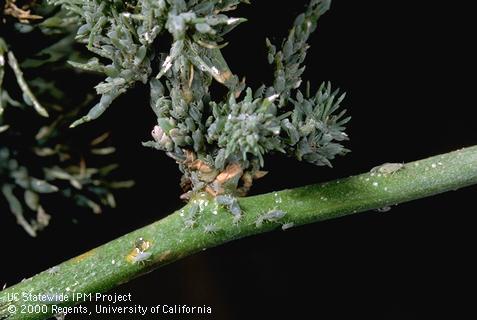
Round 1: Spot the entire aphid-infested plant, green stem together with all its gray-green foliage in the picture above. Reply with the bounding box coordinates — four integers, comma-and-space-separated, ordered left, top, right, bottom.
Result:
0, 0, 477, 320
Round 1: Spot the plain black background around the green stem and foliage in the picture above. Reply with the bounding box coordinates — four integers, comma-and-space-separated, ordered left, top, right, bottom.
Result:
0, 0, 477, 319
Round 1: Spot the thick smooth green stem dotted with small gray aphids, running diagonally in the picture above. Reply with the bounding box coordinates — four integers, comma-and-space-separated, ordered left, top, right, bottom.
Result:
0, 146, 477, 320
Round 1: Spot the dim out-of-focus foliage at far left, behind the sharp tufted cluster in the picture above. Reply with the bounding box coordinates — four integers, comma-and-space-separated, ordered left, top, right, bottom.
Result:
0, 1, 131, 236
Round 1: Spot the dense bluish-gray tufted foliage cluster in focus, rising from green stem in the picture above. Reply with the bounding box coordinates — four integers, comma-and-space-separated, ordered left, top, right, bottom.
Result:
49, 0, 349, 194
